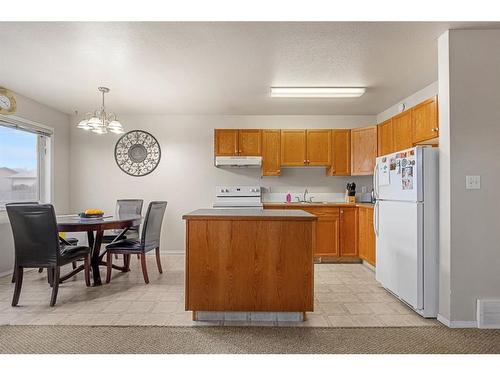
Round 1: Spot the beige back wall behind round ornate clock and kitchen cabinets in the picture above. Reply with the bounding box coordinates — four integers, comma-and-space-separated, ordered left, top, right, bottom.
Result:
70, 115, 375, 251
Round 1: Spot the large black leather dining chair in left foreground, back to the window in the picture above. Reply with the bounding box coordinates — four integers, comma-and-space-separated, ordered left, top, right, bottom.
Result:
6, 204, 90, 306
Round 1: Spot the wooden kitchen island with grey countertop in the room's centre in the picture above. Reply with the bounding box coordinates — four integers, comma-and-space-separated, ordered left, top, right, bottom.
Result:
183, 209, 317, 320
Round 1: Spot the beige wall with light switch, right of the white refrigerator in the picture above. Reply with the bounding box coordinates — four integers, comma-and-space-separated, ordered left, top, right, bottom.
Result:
439, 30, 500, 324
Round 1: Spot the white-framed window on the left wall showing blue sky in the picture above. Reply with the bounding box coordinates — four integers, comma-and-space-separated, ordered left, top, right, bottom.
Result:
0, 119, 50, 209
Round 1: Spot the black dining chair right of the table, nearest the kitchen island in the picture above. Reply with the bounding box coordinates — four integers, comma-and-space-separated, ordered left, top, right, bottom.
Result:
106, 201, 167, 284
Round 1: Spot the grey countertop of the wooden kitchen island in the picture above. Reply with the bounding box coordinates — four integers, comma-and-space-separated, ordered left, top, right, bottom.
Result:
182, 208, 316, 220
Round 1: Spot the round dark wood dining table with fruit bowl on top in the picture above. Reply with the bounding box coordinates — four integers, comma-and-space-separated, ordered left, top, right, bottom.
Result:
56, 214, 142, 286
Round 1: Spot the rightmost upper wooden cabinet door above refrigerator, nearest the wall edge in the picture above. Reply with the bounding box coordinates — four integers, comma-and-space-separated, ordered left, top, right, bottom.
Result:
411, 97, 439, 143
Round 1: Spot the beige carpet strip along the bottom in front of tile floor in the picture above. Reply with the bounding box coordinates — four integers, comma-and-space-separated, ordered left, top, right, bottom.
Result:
0, 326, 500, 354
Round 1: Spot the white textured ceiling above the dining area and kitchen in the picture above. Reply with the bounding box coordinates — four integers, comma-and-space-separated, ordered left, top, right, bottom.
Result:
0, 22, 500, 115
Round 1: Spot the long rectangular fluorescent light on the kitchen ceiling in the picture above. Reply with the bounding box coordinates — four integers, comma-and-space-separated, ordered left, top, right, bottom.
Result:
271, 87, 366, 98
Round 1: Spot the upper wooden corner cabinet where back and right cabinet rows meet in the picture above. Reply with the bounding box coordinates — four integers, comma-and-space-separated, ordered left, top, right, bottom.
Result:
351, 125, 377, 176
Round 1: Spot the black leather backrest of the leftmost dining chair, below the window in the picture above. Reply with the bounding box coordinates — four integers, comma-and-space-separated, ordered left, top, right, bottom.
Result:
5, 203, 59, 267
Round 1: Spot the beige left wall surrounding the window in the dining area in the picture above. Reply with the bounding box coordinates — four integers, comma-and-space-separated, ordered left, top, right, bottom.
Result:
0, 94, 70, 275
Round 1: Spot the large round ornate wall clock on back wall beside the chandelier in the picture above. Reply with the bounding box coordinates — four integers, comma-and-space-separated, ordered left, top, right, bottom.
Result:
115, 130, 161, 177
